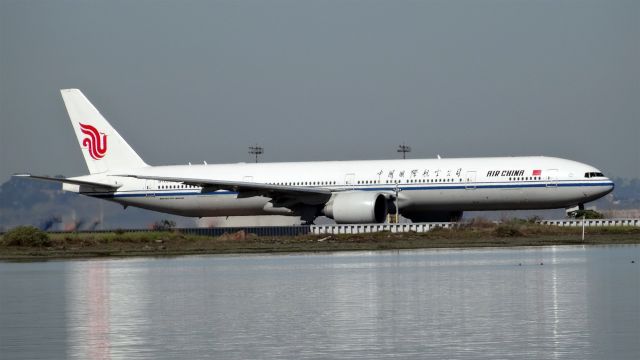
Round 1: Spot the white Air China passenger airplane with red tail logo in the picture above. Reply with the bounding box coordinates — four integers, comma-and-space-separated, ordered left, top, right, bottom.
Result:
15, 89, 614, 223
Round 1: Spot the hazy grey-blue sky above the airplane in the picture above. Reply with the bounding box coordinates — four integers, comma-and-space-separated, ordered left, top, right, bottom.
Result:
0, 0, 640, 182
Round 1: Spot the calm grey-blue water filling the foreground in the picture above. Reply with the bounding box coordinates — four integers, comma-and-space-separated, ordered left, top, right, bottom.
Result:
0, 246, 640, 359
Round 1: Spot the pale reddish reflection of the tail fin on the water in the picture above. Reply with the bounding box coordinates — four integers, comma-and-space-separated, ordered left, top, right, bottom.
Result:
67, 259, 153, 359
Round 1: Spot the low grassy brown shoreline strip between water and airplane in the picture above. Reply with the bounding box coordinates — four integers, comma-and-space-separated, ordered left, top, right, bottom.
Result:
0, 223, 640, 261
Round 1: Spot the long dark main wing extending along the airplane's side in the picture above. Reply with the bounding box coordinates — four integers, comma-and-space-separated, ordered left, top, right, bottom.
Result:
114, 175, 332, 206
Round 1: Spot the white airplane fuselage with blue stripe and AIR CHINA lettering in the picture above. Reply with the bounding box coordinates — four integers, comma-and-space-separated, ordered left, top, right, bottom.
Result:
64, 156, 614, 217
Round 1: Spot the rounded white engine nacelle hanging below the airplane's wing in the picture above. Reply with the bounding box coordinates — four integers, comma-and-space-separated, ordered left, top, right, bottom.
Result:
322, 191, 387, 224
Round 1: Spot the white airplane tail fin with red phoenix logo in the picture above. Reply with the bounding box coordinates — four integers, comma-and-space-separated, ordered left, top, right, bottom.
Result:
60, 89, 148, 174
